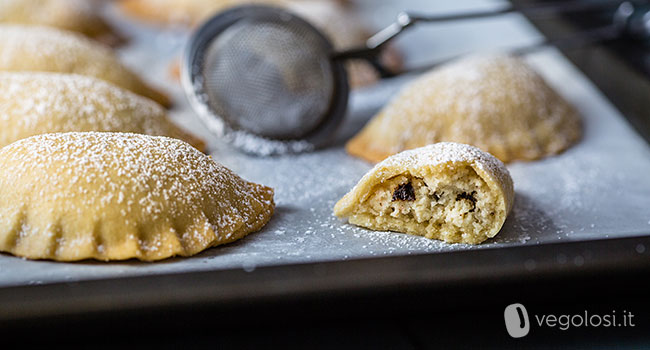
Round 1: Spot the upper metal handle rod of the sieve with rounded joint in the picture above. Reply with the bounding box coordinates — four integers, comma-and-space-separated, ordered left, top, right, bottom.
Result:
332, 0, 623, 61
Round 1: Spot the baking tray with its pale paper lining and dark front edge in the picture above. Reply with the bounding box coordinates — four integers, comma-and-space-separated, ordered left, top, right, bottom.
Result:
0, 0, 650, 326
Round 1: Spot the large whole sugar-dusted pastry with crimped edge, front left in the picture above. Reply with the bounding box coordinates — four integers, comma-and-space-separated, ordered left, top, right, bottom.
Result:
0, 132, 274, 261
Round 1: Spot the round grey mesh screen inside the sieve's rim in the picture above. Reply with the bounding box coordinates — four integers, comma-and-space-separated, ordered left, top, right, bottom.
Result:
202, 18, 335, 139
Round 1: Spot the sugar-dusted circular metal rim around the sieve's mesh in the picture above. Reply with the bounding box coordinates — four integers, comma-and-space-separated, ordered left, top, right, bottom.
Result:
181, 5, 350, 155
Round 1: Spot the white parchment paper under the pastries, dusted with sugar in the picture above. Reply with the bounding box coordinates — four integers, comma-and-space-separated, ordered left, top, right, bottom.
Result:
0, 0, 650, 287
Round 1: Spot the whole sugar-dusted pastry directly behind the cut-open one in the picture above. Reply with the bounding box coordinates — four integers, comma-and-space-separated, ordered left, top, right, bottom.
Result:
346, 55, 581, 162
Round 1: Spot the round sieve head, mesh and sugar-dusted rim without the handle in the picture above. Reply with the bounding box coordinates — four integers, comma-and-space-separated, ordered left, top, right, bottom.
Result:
183, 6, 348, 154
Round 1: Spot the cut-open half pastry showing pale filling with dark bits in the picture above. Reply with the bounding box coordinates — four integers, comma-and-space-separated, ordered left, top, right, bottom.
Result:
334, 142, 514, 244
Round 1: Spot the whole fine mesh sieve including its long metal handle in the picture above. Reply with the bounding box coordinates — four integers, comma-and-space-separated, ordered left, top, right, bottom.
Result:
182, 0, 650, 155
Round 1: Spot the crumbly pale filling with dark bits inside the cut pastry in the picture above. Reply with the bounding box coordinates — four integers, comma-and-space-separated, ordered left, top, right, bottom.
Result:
350, 166, 505, 243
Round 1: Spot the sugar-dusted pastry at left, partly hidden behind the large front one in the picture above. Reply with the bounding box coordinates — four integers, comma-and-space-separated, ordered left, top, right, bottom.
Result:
0, 72, 205, 151
